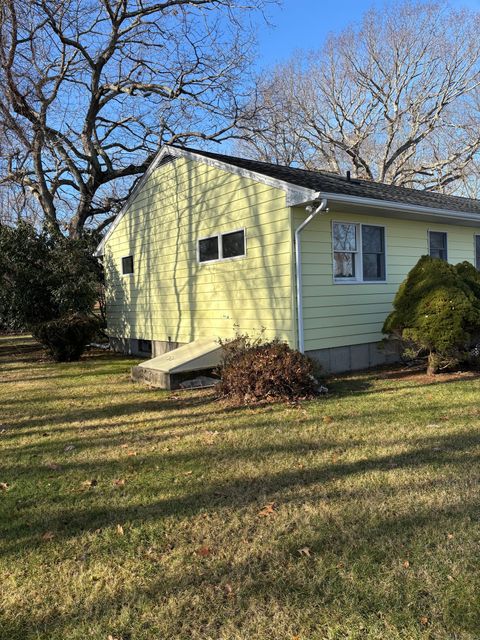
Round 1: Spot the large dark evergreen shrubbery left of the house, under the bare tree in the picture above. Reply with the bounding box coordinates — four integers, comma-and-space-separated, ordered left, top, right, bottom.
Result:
0, 223, 103, 360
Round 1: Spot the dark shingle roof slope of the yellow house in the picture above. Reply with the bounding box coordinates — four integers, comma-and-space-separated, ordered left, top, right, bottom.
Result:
179, 148, 480, 214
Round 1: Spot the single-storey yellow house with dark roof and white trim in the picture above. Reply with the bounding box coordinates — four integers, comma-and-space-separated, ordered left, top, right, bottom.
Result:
97, 146, 480, 384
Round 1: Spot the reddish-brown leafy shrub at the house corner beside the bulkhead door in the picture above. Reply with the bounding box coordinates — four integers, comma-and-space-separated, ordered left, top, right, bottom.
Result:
217, 335, 319, 403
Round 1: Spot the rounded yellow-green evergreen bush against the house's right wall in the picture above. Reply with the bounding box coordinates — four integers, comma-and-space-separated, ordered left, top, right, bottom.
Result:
383, 256, 480, 373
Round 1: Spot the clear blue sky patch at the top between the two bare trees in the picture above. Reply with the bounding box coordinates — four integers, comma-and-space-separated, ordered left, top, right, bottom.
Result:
257, 0, 480, 69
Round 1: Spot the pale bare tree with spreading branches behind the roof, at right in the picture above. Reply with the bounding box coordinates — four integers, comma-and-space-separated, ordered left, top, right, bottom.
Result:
240, 2, 480, 190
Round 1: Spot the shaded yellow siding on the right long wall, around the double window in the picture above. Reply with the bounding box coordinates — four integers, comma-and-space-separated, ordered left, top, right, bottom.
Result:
293, 208, 478, 351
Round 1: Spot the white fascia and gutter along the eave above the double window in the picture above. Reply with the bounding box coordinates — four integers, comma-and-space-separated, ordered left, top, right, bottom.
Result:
321, 192, 480, 227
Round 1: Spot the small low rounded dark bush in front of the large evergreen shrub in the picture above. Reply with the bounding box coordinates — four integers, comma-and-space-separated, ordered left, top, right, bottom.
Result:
32, 313, 99, 362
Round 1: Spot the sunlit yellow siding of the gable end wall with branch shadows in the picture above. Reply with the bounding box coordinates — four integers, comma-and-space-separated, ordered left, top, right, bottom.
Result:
104, 158, 294, 342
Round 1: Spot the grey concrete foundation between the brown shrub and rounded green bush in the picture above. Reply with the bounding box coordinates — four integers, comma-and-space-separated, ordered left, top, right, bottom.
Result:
305, 342, 400, 373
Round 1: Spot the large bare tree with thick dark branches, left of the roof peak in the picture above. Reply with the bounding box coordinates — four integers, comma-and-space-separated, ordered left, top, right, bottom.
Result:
0, 0, 268, 237
